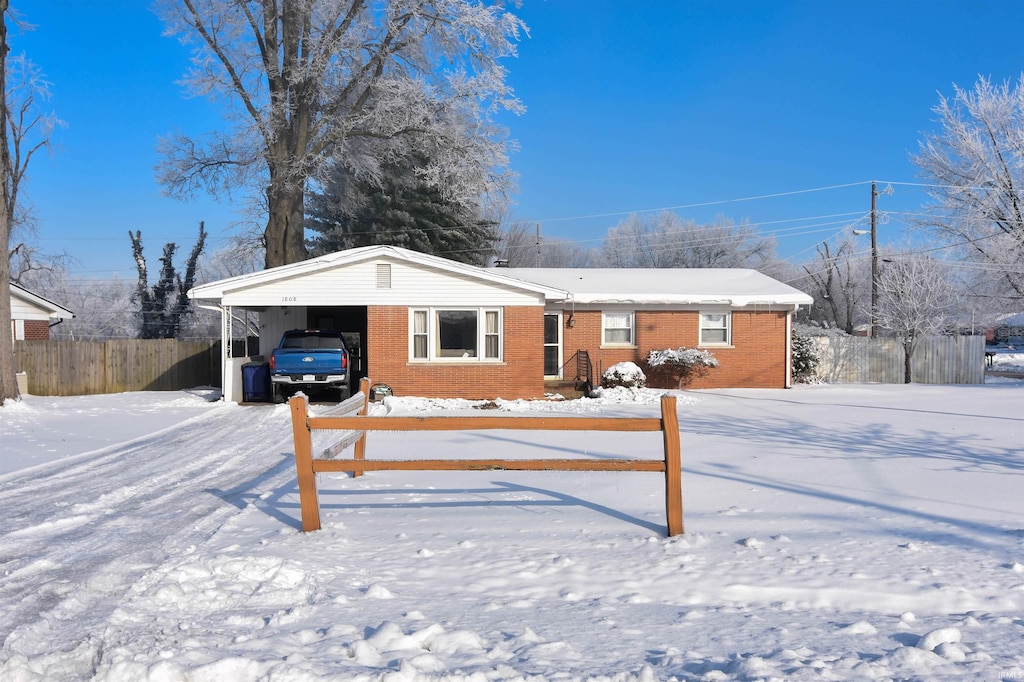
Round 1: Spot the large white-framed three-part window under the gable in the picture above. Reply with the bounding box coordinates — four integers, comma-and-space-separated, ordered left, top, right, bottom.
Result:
409, 308, 502, 361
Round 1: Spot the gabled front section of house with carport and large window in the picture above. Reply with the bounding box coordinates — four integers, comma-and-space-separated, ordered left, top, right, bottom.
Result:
188, 246, 567, 402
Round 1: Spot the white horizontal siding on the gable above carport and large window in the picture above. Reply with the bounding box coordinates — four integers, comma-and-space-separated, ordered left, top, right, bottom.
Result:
223, 259, 544, 307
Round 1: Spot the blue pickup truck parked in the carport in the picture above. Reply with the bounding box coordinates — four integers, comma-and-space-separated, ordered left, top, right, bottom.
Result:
270, 329, 351, 402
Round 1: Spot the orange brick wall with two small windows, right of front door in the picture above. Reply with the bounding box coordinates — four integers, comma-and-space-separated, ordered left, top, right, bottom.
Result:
562, 310, 786, 388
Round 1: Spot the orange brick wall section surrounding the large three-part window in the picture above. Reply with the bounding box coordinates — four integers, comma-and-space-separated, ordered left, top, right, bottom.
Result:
367, 306, 544, 399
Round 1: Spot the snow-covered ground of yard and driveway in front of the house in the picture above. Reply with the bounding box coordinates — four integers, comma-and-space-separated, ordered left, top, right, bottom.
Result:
0, 372, 1024, 682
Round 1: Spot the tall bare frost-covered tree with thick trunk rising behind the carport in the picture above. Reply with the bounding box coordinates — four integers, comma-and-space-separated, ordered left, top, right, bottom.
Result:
159, 0, 525, 267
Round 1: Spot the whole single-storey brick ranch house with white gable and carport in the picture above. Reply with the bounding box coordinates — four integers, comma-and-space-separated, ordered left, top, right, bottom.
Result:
188, 246, 812, 401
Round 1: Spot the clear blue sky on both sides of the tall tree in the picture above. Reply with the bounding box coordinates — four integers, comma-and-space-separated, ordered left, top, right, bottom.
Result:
11, 0, 1024, 279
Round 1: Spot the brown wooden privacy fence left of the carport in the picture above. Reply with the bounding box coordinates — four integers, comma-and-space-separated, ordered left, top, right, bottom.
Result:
14, 339, 220, 395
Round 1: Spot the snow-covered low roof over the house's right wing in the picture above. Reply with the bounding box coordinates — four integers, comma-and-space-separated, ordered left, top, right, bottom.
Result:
505, 267, 813, 306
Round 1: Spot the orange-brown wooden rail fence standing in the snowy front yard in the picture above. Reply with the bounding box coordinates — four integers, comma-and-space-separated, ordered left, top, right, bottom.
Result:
289, 379, 683, 537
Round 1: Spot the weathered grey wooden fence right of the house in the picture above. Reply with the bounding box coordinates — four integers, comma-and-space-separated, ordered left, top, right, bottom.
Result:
812, 336, 985, 384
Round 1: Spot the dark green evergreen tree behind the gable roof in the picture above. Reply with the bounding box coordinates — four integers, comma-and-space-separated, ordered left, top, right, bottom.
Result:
307, 155, 498, 265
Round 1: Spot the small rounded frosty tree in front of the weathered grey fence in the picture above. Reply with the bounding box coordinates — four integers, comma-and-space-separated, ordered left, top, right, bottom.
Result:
877, 246, 963, 383
